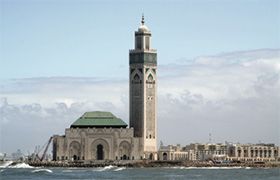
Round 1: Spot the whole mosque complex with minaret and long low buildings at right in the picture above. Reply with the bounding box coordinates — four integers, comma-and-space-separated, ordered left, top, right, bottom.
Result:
53, 16, 280, 162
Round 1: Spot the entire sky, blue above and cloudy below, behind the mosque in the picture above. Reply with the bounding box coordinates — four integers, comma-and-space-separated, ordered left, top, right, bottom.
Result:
0, 0, 280, 154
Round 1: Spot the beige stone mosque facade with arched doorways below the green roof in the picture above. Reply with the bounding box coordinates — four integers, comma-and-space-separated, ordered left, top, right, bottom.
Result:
53, 128, 142, 160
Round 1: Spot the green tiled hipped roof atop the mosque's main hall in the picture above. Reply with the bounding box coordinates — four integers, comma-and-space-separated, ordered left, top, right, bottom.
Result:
71, 111, 127, 127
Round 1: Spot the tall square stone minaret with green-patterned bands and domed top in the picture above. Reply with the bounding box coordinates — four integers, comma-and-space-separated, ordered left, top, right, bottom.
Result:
129, 15, 157, 159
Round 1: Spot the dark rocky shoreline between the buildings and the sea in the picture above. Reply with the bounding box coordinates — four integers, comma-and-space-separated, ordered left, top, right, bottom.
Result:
27, 161, 280, 168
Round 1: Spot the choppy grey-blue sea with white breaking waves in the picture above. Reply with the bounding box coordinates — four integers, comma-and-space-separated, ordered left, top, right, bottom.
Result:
0, 162, 280, 180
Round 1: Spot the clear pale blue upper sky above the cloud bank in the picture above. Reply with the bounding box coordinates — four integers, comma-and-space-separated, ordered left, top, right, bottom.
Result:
1, 1, 280, 79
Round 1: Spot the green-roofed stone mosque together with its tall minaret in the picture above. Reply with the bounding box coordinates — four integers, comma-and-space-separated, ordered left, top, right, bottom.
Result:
53, 16, 158, 161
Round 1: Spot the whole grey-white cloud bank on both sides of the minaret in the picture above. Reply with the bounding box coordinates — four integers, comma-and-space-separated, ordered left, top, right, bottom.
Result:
0, 49, 280, 152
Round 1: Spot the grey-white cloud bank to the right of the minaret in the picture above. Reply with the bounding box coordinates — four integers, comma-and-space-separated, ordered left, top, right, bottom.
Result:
158, 49, 280, 145
